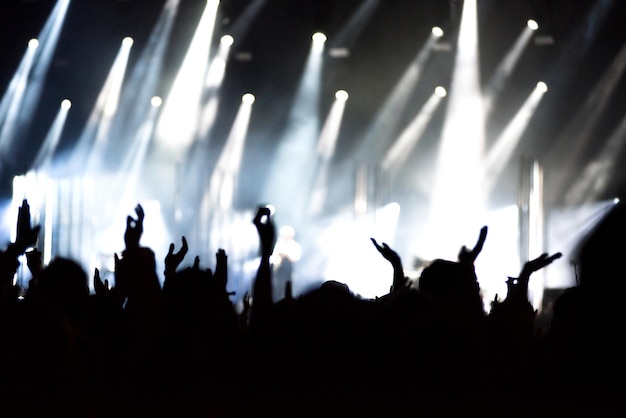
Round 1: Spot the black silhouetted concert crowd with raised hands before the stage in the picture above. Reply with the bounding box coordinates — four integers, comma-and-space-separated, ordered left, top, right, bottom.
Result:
0, 200, 626, 417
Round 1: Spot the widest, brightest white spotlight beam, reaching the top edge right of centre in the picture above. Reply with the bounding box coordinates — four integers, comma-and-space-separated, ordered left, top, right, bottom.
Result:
419, 0, 485, 259
